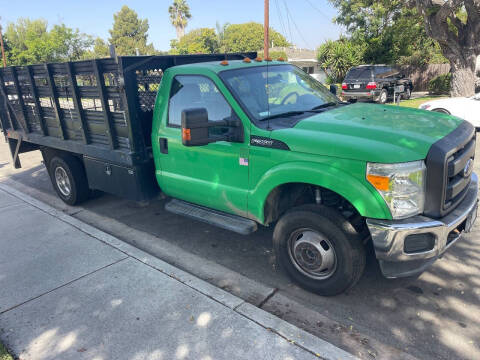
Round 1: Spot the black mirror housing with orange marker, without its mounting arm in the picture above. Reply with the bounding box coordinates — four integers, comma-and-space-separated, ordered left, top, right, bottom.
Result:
182, 108, 210, 146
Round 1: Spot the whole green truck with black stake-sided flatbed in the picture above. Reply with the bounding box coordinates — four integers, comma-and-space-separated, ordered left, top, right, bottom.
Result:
0, 54, 478, 295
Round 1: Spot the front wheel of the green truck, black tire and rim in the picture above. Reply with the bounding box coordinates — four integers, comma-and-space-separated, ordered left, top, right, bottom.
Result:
273, 205, 366, 296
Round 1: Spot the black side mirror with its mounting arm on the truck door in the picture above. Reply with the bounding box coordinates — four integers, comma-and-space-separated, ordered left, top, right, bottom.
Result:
182, 108, 243, 146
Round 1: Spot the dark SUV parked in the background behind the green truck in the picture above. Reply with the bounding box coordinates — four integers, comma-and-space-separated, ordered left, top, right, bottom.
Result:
342, 65, 413, 104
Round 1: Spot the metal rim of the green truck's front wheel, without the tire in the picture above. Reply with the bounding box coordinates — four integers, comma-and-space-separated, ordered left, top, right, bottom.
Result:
288, 229, 337, 280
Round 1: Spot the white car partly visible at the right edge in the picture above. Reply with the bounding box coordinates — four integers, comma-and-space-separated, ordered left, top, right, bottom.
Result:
419, 93, 480, 130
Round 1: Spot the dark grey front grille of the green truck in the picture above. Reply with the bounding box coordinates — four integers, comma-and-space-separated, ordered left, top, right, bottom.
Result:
424, 121, 475, 218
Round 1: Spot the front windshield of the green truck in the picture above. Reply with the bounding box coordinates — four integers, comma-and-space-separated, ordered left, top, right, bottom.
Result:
220, 65, 338, 121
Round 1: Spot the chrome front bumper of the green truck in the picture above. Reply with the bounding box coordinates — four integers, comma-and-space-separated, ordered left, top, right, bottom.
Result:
367, 173, 478, 278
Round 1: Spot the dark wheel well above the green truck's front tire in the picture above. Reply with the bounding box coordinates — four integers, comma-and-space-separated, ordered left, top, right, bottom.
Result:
264, 183, 365, 232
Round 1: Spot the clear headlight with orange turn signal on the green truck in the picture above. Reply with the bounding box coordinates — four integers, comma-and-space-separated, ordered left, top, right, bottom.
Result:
367, 161, 426, 219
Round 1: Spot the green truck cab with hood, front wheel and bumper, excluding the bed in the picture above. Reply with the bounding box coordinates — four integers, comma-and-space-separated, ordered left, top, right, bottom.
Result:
152, 60, 477, 294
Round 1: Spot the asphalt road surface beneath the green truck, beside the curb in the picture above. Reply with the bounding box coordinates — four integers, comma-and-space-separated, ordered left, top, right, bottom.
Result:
0, 141, 480, 359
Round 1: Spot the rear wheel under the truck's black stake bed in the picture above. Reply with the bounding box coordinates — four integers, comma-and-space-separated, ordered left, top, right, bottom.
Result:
48, 155, 90, 206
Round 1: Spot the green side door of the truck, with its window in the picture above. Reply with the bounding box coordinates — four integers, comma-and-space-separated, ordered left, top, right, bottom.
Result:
158, 75, 248, 216
